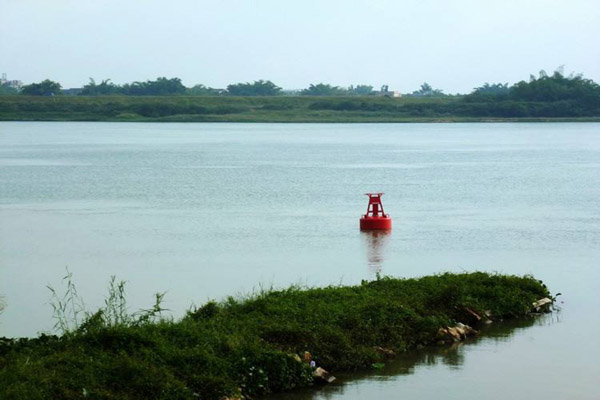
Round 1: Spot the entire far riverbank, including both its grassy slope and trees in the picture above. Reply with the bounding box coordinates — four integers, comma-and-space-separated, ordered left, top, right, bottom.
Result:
0, 71, 600, 123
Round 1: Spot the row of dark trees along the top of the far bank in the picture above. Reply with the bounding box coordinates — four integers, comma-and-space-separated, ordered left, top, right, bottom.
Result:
0, 70, 599, 101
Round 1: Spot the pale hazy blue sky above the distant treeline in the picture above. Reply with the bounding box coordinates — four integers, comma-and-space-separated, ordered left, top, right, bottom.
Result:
0, 0, 600, 93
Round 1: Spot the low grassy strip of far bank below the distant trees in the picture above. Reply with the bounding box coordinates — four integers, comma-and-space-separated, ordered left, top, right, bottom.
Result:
0, 96, 600, 122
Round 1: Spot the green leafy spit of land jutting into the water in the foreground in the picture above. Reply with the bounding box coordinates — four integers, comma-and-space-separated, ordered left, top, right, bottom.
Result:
0, 272, 552, 400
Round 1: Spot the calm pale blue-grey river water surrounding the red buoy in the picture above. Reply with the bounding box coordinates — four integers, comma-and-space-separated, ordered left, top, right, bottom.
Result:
0, 122, 600, 400
